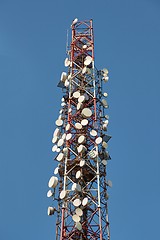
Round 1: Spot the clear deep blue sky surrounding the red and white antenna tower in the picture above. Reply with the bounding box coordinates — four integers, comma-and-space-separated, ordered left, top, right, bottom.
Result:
0, 0, 160, 240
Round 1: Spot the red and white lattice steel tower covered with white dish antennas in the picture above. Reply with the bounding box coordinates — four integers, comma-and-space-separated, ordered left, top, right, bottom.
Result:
47, 18, 112, 240
